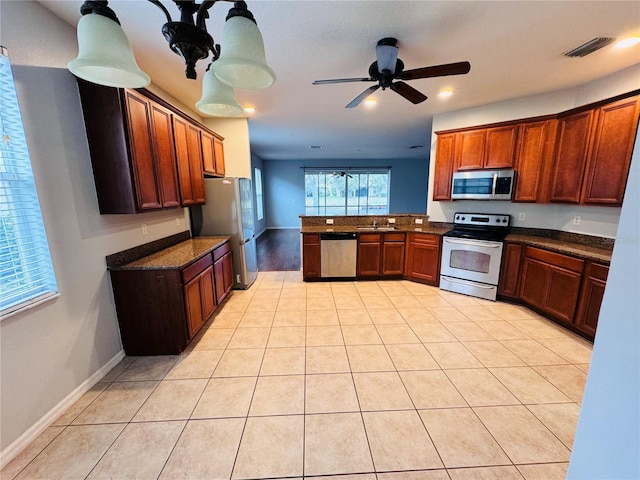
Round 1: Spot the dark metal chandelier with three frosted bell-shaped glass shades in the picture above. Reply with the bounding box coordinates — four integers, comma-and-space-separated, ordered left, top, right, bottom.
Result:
68, 0, 276, 116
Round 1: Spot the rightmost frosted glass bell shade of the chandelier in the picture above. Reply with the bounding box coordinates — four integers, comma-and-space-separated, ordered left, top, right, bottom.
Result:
216, 16, 276, 90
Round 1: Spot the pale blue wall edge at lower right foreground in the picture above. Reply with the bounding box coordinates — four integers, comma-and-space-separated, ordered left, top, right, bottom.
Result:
567, 122, 640, 480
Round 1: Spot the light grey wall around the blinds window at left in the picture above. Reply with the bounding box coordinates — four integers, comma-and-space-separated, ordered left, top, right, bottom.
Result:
0, 1, 195, 461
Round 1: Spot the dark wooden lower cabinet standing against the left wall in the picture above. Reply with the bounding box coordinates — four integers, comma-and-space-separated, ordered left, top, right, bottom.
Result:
109, 242, 233, 355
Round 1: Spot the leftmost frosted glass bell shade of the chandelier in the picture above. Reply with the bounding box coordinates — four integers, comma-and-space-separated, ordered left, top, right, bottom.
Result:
67, 13, 151, 88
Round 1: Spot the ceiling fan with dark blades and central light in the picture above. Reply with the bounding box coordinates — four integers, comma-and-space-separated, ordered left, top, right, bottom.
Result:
313, 37, 471, 108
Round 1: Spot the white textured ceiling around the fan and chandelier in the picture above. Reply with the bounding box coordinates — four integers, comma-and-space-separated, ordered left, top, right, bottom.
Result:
40, 0, 640, 160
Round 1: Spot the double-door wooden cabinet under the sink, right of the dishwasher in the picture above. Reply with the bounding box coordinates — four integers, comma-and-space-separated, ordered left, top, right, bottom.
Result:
356, 233, 406, 278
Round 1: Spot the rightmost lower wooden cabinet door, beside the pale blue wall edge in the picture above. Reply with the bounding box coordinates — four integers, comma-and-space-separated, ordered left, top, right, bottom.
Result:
575, 262, 609, 337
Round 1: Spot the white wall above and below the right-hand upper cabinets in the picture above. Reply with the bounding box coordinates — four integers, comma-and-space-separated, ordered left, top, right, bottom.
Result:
427, 64, 640, 238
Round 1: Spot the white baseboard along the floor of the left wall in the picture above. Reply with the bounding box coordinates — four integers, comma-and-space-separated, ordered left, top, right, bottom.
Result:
0, 350, 125, 469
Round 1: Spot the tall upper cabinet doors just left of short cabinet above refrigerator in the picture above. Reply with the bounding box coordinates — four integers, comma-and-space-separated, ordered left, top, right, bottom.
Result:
173, 115, 205, 206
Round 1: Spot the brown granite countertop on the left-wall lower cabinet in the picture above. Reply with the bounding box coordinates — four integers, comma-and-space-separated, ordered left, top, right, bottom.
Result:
110, 236, 231, 270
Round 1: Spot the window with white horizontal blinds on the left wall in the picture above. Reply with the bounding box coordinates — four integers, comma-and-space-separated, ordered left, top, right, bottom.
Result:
0, 47, 58, 318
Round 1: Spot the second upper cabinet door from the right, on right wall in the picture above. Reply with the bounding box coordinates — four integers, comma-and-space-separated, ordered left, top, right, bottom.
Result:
550, 110, 594, 203
